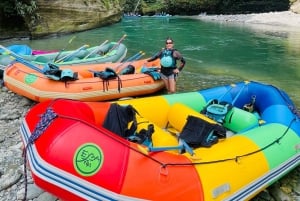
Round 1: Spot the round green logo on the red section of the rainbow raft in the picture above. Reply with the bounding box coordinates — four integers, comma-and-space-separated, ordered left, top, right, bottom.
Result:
73, 143, 104, 176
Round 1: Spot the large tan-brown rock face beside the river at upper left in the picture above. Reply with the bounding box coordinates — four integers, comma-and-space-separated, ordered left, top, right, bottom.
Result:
31, 0, 122, 38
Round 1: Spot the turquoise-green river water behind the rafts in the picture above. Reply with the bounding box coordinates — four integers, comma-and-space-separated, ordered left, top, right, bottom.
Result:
4, 17, 300, 106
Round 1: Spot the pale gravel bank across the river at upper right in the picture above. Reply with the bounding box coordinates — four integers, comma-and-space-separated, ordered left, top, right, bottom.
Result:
186, 11, 300, 32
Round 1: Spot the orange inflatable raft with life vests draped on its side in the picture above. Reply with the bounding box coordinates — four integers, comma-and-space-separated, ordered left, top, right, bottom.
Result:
3, 59, 164, 102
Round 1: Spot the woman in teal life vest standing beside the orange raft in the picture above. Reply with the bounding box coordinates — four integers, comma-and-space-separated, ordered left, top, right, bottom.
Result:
147, 37, 185, 93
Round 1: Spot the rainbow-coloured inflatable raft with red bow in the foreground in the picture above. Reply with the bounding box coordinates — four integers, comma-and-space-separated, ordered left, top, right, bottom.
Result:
21, 81, 300, 201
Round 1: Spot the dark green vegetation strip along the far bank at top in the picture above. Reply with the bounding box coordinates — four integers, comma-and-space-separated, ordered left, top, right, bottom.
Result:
124, 0, 294, 15
